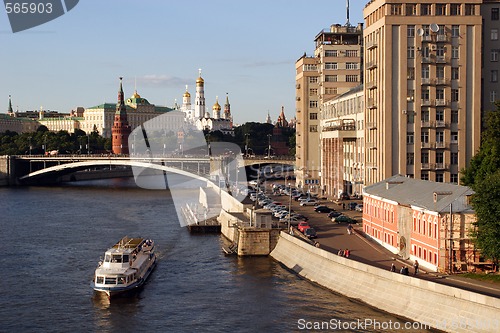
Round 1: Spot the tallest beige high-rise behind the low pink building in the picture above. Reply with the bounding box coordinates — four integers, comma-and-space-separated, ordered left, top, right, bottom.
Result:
363, 0, 482, 185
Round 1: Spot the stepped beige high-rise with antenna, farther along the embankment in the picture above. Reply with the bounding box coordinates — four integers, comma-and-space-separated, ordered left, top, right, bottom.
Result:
295, 23, 363, 192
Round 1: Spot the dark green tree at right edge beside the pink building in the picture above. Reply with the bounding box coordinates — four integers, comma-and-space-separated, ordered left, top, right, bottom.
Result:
471, 170, 500, 266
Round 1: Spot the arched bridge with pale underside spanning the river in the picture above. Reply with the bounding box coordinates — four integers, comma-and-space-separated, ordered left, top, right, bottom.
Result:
0, 155, 295, 185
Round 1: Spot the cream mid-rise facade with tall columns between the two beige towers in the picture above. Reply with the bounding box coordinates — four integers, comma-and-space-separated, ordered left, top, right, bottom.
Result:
320, 85, 364, 197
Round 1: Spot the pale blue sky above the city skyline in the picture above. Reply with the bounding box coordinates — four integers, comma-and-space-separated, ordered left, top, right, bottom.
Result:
0, 0, 367, 124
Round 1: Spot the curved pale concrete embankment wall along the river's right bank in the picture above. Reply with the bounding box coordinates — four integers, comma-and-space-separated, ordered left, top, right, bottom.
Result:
270, 232, 500, 332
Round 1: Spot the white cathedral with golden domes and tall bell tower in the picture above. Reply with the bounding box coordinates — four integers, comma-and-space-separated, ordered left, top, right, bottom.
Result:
180, 70, 234, 135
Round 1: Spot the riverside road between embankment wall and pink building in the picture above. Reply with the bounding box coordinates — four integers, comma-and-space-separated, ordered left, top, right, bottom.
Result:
266, 182, 500, 298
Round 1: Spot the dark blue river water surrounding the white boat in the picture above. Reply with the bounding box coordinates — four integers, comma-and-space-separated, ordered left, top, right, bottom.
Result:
0, 179, 434, 332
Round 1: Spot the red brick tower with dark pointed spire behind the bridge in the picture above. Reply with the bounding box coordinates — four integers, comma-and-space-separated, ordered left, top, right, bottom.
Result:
111, 77, 132, 154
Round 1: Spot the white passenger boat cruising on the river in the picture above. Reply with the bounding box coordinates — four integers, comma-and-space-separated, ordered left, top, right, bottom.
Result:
91, 237, 156, 297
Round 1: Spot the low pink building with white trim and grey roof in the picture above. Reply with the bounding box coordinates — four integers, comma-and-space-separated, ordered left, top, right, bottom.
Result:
363, 175, 484, 272
